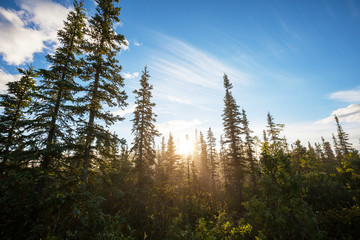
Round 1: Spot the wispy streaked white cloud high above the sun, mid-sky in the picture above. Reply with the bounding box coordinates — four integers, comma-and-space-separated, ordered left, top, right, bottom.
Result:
151, 34, 249, 89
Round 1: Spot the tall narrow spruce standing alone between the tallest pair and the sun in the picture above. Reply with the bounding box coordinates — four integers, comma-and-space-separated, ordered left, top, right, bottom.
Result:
131, 67, 159, 189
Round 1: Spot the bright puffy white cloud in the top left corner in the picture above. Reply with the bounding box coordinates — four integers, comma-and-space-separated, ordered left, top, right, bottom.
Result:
0, 0, 70, 65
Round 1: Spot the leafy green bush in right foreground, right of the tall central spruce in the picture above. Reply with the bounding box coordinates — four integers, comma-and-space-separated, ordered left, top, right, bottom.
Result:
246, 148, 322, 239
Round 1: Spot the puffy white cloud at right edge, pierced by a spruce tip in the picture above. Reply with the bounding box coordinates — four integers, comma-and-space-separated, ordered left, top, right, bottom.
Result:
316, 104, 360, 124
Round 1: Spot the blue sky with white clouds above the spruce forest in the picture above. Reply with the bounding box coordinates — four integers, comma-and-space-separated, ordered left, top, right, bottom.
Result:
0, 0, 360, 152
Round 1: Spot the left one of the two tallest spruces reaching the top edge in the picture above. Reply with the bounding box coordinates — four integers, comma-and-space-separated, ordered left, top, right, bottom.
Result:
34, 0, 86, 169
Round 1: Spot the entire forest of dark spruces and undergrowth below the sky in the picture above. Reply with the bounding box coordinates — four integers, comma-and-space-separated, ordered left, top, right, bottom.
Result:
0, 0, 360, 239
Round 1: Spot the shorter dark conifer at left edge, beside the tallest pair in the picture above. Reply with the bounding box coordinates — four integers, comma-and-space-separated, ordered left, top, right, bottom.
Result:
0, 66, 37, 164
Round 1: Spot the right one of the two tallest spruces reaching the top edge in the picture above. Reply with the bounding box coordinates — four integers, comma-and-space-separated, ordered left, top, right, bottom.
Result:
78, 0, 127, 186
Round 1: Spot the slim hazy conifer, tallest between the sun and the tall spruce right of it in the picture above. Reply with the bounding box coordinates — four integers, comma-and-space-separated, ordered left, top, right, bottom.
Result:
207, 128, 218, 194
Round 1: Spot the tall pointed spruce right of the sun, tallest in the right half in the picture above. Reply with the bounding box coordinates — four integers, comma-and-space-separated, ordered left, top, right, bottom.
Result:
222, 74, 246, 198
